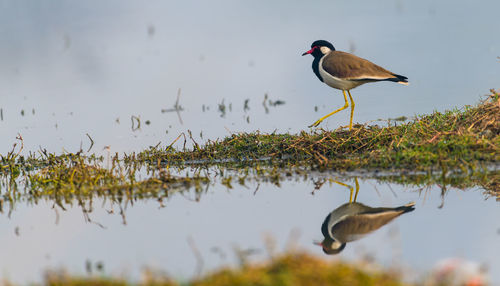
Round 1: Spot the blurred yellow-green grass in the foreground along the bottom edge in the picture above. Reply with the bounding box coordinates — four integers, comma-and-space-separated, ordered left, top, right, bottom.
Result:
36, 253, 407, 286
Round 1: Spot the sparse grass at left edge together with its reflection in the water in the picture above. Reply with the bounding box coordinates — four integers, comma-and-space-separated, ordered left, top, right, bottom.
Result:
0, 154, 208, 215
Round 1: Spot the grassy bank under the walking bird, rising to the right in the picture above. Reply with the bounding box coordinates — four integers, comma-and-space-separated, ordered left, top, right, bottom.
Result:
137, 91, 500, 172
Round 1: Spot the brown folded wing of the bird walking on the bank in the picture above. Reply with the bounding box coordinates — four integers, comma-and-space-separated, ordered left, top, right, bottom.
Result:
322, 51, 395, 80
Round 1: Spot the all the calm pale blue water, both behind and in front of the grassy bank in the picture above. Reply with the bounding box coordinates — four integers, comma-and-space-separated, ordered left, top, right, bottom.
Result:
0, 0, 500, 283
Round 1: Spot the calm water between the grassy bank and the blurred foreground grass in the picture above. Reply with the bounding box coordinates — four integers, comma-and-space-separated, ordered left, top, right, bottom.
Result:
0, 180, 500, 282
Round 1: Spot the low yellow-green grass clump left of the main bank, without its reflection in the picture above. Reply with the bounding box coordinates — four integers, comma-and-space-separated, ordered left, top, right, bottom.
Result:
27, 156, 206, 198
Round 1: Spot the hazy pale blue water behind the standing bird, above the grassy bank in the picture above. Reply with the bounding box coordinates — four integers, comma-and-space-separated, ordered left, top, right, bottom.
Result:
0, 0, 500, 153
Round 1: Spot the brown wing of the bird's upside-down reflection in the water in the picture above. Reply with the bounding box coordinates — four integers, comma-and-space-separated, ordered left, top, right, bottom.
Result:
332, 211, 403, 242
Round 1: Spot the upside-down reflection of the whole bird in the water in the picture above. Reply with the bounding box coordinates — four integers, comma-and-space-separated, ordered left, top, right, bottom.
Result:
316, 178, 415, 254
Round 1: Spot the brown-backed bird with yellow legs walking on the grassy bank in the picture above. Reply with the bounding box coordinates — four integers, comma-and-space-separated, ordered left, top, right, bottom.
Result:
302, 40, 409, 131
